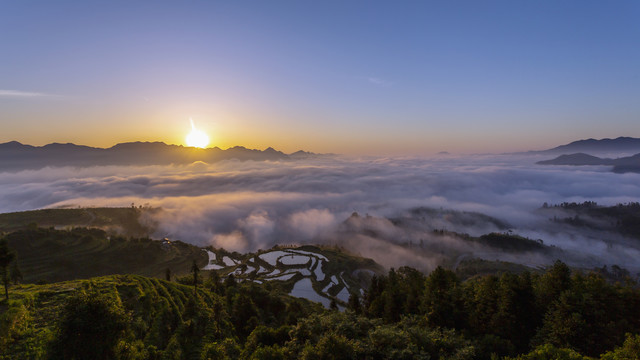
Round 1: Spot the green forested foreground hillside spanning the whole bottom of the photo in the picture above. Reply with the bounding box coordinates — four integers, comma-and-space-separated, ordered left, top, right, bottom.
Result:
0, 262, 640, 360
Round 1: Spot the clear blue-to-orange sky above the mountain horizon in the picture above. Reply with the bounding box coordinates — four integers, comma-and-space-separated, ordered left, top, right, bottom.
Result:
0, 0, 640, 155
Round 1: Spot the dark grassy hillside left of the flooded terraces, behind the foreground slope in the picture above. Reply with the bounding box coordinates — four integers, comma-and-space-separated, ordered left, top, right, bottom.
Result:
6, 228, 208, 283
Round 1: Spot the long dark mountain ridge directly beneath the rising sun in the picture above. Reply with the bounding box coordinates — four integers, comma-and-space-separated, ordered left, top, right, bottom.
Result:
0, 141, 319, 171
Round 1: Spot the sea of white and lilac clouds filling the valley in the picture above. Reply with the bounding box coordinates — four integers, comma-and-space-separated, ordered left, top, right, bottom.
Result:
0, 155, 640, 269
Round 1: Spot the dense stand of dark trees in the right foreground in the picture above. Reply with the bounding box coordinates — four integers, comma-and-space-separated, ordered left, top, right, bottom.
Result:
349, 261, 640, 359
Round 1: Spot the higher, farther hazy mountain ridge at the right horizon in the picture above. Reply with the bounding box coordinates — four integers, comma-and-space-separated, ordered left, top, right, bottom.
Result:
519, 136, 640, 155
